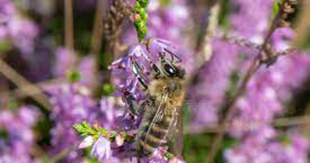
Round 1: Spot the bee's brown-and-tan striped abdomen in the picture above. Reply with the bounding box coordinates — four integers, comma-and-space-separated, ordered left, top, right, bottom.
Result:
139, 116, 172, 154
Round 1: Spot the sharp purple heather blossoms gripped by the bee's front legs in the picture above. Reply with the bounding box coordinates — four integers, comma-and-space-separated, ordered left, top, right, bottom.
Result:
110, 38, 179, 99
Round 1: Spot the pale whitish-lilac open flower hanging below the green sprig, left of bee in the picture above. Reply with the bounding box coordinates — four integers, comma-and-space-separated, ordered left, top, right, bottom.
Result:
90, 136, 111, 160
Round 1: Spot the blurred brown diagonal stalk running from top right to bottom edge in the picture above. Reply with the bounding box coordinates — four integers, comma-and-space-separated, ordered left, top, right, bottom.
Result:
206, 0, 296, 163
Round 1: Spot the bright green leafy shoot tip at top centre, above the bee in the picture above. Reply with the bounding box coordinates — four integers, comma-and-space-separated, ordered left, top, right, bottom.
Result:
134, 0, 148, 41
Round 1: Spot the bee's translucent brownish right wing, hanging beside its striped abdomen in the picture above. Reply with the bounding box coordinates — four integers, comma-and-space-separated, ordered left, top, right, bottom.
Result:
170, 108, 183, 157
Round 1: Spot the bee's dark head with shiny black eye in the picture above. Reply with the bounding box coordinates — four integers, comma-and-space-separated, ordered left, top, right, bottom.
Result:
162, 62, 185, 79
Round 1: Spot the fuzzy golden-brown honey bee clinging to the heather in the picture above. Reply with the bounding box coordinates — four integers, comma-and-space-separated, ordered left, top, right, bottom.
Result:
125, 52, 185, 159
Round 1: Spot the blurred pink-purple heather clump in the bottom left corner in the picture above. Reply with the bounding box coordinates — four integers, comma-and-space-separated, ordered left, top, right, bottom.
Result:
0, 106, 38, 163
